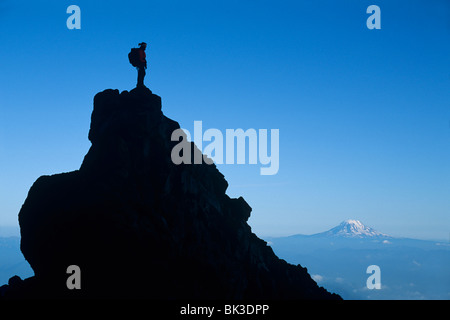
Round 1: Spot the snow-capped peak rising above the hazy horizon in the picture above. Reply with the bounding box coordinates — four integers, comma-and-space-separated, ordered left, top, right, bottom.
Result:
316, 219, 390, 238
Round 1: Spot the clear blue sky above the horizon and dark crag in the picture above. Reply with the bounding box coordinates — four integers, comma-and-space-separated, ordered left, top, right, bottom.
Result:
0, 0, 450, 239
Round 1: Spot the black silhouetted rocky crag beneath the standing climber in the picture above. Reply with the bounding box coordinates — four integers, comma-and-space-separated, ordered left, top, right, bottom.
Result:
0, 88, 339, 299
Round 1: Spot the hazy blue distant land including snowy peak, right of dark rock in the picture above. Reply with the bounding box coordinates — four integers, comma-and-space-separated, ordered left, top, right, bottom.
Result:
265, 219, 450, 300
